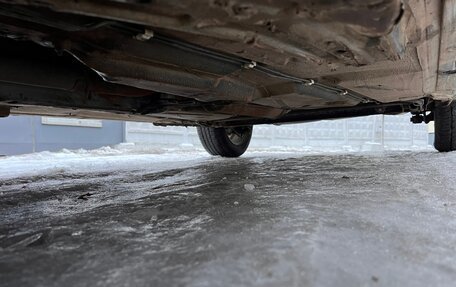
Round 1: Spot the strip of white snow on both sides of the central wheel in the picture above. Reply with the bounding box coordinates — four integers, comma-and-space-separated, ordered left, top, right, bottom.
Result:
0, 143, 429, 180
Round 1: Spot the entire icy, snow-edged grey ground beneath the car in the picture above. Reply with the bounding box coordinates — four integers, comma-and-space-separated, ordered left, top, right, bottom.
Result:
0, 145, 456, 287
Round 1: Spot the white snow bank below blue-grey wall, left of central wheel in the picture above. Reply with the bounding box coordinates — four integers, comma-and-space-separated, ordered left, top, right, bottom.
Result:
0, 145, 209, 179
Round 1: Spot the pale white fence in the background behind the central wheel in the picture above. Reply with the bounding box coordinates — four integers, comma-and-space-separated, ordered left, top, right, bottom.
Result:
125, 115, 429, 150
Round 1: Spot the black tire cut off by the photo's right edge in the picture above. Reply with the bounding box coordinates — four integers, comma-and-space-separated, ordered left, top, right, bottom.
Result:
434, 102, 456, 152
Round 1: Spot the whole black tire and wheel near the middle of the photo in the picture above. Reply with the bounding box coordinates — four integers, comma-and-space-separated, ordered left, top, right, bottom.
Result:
197, 126, 253, 157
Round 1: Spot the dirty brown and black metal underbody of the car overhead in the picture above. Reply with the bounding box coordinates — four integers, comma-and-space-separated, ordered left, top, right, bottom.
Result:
0, 0, 456, 125
